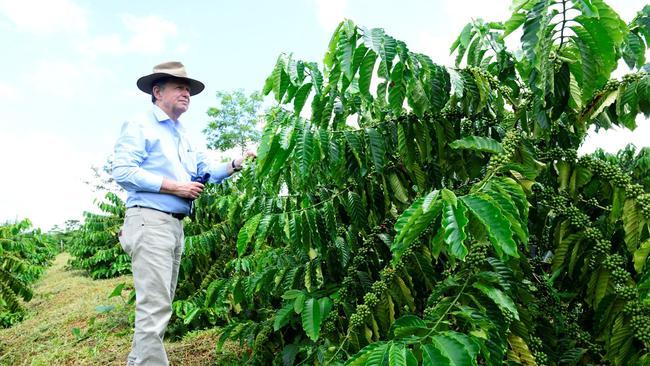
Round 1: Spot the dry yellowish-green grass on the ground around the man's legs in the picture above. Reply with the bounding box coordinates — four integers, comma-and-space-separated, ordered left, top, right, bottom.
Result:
0, 253, 232, 366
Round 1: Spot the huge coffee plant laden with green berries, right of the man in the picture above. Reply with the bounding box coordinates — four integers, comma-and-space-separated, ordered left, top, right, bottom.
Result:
161, 0, 650, 365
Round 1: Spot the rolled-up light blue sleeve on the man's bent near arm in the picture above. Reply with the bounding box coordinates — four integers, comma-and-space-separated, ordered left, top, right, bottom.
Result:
113, 121, 163, 192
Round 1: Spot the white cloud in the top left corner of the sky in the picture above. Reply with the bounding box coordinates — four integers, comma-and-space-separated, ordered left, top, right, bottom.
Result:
0, 0, 88, 34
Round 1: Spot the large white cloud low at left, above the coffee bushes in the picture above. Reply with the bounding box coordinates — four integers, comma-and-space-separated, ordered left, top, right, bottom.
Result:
0, 133, 102, 230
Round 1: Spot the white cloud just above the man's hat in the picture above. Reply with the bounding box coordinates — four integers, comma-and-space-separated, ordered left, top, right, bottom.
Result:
80, 14, 178, 56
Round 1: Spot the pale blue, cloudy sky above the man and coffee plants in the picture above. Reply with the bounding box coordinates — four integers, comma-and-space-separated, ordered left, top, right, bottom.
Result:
0, 0, 648, 230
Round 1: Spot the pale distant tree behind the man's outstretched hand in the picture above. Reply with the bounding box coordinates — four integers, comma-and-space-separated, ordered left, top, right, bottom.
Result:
203, 89, 262, 154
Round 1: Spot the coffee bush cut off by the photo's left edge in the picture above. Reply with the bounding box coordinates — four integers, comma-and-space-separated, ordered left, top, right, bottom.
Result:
0, 219, 57, 328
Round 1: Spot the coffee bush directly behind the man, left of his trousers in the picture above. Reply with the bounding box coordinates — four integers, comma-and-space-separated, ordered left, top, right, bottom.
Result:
66, 192, 131, 279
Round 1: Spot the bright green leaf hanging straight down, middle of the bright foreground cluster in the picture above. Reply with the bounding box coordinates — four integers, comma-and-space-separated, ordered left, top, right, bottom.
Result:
440, 188, 469, 260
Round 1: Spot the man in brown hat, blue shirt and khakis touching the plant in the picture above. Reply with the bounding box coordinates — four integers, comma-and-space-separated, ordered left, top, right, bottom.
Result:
113, 62, 255, 365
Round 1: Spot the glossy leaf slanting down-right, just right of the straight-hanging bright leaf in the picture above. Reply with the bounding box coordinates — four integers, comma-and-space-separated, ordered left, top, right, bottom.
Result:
461, 194, 519, 258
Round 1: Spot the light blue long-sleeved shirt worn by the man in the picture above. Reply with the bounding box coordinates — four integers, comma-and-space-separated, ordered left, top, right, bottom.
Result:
113, 105, 228, 214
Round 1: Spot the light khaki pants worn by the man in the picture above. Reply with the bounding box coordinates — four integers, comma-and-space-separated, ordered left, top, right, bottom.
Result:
120, 207, 184, 366
